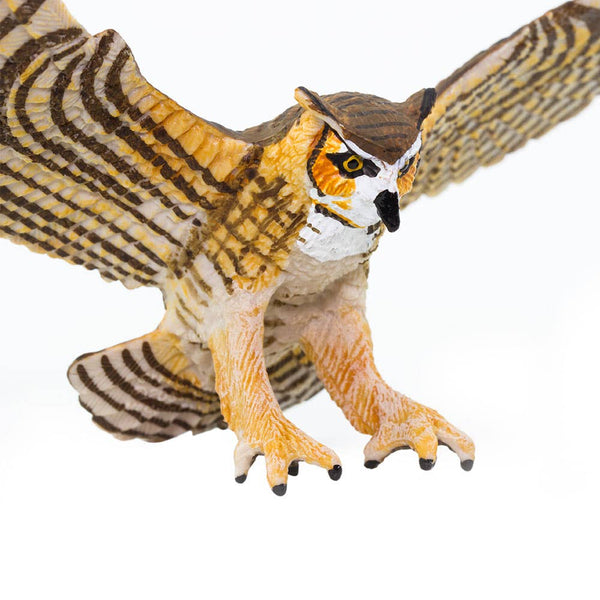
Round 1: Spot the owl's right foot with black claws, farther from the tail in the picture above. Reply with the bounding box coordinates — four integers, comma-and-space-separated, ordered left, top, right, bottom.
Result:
364, 395, 475, 471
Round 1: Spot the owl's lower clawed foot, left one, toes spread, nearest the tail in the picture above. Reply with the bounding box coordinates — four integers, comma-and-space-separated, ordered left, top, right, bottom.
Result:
234, 415, 342, 496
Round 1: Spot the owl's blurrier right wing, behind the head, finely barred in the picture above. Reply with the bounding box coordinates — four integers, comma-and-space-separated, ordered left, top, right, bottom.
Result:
402, 0, 600, 206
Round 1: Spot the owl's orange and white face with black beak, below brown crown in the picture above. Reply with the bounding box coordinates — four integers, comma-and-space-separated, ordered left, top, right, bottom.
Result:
307, 125, 421, 231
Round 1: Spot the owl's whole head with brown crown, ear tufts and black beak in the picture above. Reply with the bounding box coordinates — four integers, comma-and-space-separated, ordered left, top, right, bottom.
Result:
296, 87, 436, 231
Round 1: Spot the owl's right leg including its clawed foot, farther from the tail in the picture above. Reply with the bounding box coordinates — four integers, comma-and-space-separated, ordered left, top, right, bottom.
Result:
302, 274, 475, 471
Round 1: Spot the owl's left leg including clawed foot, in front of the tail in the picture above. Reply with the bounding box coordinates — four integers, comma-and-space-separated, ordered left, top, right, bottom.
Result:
209, 297, 342, 495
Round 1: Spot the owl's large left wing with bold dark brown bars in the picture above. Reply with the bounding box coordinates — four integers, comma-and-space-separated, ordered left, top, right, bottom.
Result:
0, 0, 260, 287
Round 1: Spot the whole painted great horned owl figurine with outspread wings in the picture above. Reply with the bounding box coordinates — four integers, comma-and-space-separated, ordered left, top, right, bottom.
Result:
0, 0, 600, 495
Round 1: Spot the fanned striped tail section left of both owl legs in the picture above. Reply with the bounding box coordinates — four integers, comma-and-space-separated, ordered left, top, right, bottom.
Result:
68, 332, 222, 441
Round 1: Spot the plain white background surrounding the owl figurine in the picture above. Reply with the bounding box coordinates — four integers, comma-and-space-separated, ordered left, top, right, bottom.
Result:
0, 0, 600, 600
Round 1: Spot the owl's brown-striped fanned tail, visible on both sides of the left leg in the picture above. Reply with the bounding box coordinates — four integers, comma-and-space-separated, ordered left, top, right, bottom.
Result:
68, 331, 323, 442
